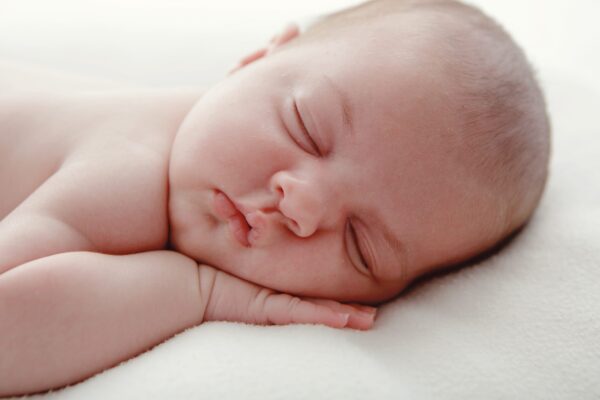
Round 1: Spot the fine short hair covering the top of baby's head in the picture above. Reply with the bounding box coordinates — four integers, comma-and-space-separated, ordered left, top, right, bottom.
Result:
291, 0, 550, 261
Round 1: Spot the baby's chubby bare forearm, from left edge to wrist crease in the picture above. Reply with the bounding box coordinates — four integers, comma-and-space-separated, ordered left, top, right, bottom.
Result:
0, 251, 202, 397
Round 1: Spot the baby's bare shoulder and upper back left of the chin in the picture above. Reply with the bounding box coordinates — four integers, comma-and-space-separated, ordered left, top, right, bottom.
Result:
0, 87, 199, 253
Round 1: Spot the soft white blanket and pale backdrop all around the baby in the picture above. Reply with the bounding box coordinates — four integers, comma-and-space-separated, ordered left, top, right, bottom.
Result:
0, 0, 600, 400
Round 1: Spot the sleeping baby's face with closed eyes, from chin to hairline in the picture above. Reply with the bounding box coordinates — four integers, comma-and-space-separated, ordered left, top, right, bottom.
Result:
169, 21, 492, 302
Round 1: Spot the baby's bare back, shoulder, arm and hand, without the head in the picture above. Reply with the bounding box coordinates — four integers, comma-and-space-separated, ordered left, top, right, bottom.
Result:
0, 63, 374, 396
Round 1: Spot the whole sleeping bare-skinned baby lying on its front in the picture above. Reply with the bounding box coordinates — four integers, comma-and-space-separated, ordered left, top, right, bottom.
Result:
0, 0, 549, 395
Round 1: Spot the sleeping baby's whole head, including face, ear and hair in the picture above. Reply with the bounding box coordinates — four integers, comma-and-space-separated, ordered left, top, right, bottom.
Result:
169, 0, 549, 303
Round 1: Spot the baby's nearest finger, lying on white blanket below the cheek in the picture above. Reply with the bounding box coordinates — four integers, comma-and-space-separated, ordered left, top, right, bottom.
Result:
264, 293, 350, 328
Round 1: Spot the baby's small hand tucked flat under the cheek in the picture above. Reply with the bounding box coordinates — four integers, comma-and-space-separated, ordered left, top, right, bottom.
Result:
200, 265, 376, 329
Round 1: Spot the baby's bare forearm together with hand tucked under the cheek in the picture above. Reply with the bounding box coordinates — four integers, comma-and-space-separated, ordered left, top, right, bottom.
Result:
0, 251, 374, 397
